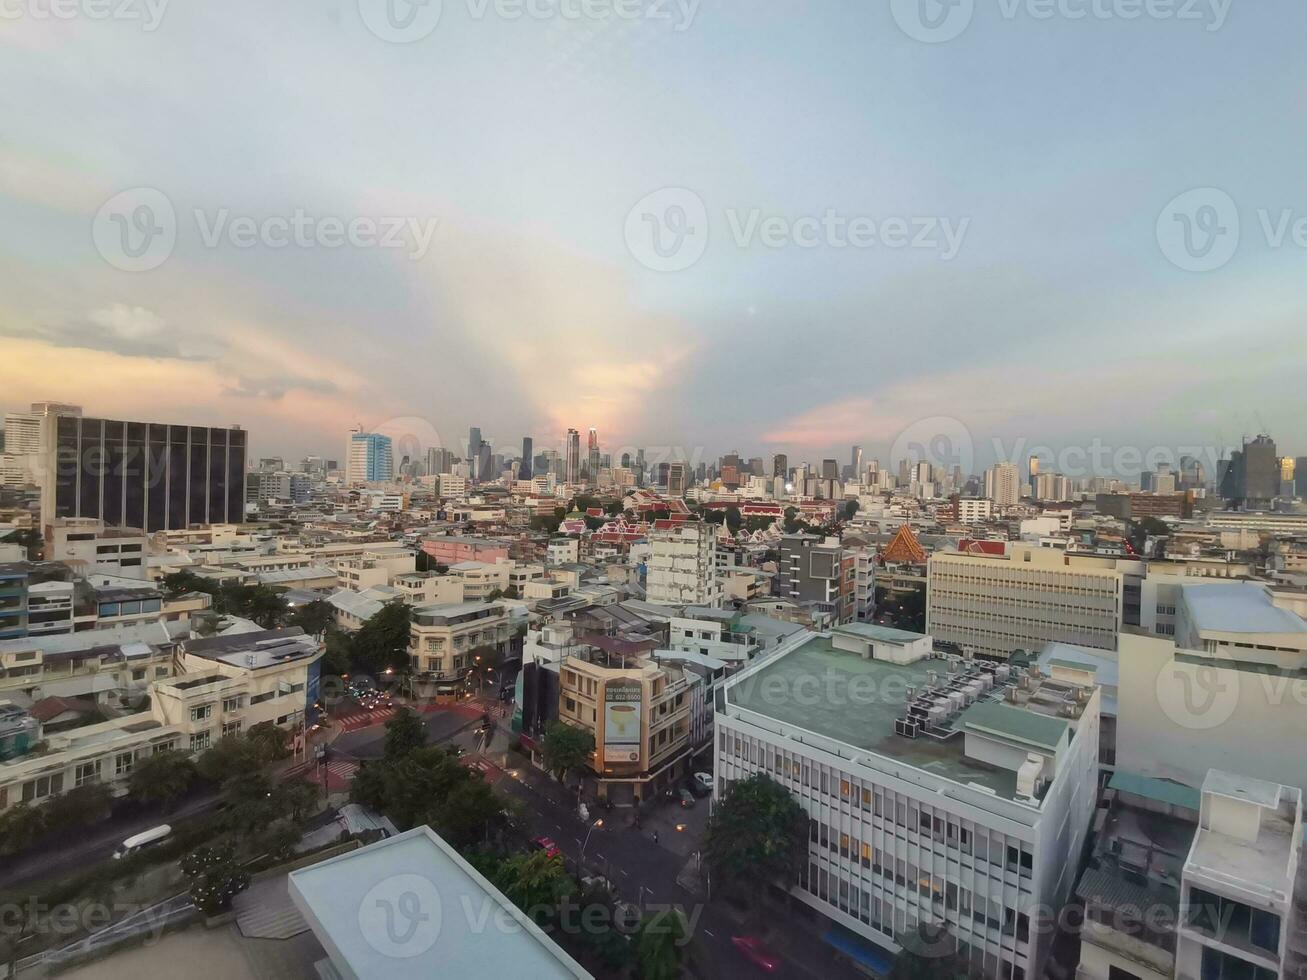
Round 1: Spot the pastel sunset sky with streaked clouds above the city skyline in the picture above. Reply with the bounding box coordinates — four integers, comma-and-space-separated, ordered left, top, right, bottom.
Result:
0, 0, 1307, 480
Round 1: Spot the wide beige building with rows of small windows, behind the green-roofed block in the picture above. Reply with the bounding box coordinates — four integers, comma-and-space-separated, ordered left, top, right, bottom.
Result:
925, 545, 1125, 659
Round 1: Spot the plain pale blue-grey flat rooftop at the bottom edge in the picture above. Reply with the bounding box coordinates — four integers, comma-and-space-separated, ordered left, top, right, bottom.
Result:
288, 826, 589, 979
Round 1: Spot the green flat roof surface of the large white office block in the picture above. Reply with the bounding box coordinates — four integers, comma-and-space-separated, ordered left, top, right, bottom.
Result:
725, 635, 1040, 800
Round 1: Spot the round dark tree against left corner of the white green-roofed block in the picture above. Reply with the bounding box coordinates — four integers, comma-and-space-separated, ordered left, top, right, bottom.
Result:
704, 774, 808, 896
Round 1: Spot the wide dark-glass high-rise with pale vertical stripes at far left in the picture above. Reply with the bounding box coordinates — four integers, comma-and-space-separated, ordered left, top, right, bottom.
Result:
41, 416, 247, 532
